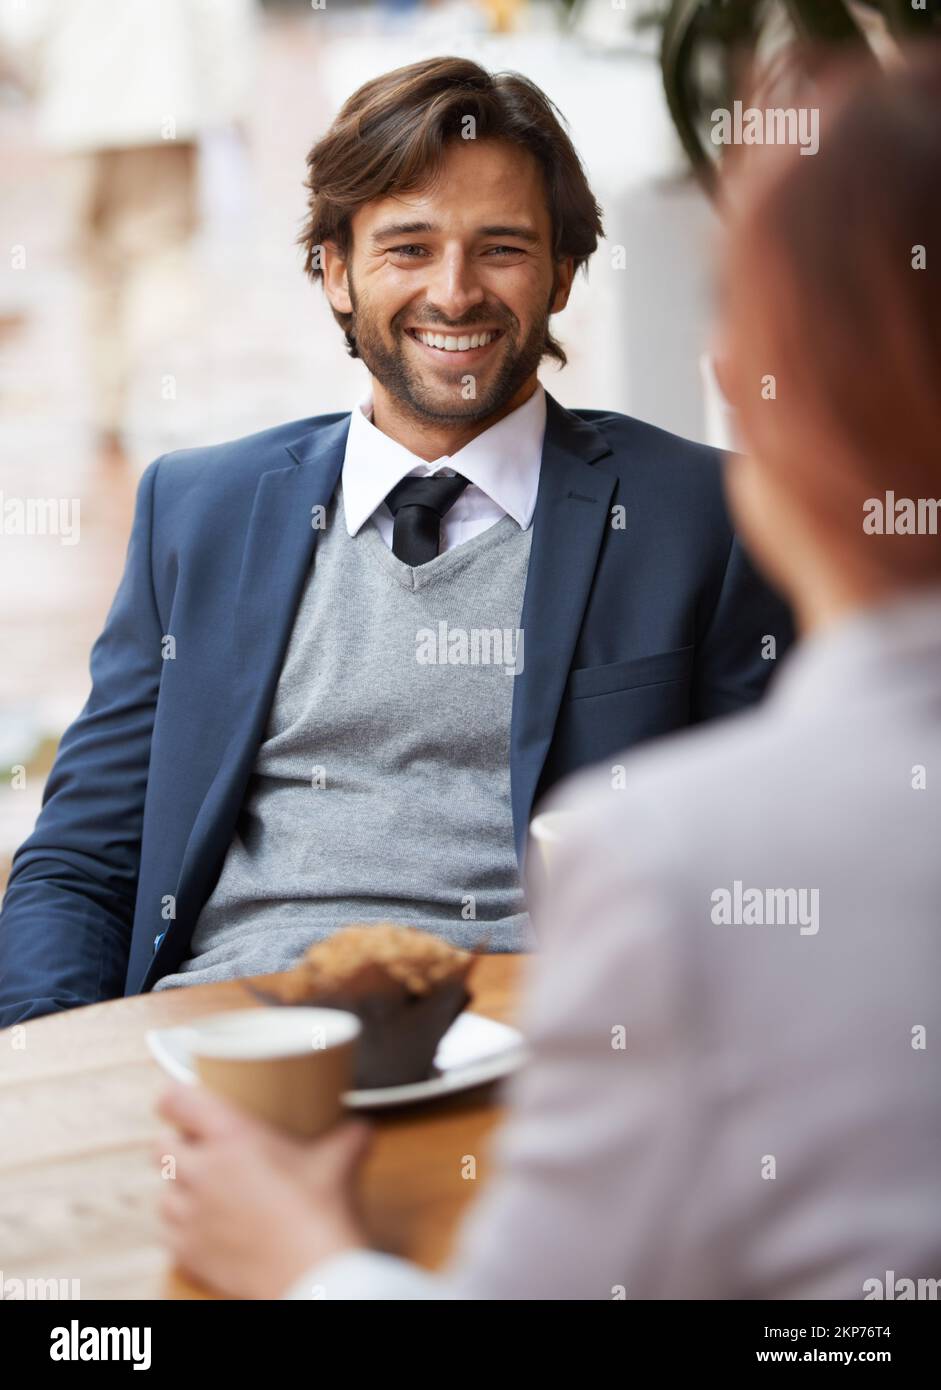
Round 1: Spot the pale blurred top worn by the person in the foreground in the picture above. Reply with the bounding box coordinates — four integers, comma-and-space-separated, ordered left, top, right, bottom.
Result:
285, 591, 941, 1300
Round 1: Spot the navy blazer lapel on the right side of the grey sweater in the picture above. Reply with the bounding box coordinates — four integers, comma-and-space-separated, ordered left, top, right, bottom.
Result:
510, 393, 617, 867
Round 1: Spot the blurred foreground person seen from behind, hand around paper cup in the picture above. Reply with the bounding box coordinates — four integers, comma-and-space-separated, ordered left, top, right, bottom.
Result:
161, 56, 941, 1298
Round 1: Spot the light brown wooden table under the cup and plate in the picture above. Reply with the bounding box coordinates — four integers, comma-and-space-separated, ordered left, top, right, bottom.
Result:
0, 955, 525, 1298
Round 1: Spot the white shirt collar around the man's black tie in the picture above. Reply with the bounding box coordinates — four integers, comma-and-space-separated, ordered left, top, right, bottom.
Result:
342, 384, 546, 553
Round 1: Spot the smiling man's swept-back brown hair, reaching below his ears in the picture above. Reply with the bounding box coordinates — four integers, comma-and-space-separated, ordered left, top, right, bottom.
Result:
297, 58, 603, 364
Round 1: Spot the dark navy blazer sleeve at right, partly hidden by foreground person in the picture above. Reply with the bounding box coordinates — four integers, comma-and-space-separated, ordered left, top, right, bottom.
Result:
691, 537, 794, 723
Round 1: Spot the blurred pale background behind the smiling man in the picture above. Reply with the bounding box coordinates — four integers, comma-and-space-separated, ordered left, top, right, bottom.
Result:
0, 0, 910, 883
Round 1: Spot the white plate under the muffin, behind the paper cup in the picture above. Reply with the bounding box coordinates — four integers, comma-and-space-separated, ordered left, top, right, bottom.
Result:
146, 1012, 525, 1111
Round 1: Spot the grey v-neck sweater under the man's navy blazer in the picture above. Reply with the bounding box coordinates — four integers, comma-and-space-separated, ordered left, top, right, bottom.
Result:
154, 489, 532, 990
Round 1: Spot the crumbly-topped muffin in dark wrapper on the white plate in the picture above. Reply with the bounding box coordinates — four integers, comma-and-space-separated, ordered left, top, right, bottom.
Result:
278, 922, 474, 1090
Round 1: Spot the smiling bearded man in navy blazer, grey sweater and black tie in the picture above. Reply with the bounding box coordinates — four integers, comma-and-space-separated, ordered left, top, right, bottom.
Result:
0, 58, 789, 1024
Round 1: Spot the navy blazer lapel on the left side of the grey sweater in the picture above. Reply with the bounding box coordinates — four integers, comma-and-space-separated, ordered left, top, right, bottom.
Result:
155, 416, 349, 967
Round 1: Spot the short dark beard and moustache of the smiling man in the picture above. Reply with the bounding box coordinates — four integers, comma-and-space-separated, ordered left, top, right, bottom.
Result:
349, 279, 555, 421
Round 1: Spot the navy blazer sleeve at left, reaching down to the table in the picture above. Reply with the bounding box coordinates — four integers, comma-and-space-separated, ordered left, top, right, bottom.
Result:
0, 459, 163, 1027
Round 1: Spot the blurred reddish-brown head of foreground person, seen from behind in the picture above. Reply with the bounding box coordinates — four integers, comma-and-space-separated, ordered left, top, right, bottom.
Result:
726, 43, 941, 580
